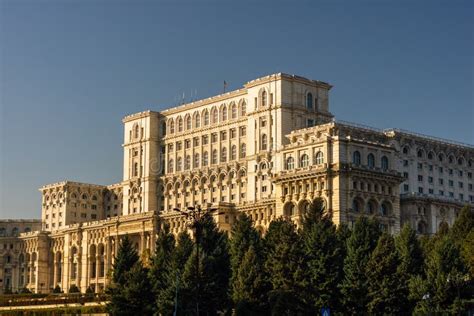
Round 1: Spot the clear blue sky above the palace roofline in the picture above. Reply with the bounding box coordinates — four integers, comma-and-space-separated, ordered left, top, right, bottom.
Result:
0, 0, 474, 218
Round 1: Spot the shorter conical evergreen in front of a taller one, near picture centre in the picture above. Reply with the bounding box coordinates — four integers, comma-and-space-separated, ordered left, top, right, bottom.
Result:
232, 246, 266, 315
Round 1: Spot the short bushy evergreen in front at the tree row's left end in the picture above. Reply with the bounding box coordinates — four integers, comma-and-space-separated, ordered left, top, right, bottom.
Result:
107, 262, 154, 316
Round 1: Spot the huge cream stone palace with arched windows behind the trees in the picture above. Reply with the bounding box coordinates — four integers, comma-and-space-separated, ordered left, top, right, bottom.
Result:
0, 73, 474, 293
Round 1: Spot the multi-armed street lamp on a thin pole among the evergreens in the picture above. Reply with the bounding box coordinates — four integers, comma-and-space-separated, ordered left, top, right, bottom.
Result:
173, 205, 224, 316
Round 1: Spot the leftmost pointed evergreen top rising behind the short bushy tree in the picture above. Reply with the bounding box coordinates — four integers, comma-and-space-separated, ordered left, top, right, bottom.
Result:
112, 235, 139, 285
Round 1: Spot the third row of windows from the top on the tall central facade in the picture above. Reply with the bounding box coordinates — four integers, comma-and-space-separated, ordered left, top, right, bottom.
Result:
168, 144, 247, 173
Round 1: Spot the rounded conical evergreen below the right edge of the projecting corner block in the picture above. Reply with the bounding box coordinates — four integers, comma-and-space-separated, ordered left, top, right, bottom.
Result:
366, 233, 402, 315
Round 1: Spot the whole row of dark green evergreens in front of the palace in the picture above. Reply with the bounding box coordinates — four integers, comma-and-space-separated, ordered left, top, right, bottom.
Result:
107, 200, 474, 315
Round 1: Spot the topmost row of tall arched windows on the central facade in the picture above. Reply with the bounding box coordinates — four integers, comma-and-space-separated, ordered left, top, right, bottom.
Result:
168, 102, 247, 134
